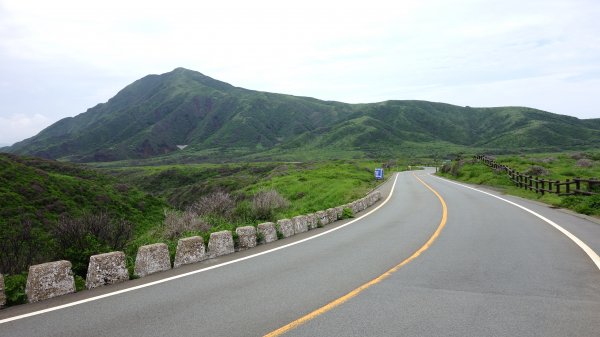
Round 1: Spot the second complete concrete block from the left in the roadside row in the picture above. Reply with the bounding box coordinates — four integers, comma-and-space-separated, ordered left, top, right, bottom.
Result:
85, 252, 129, 289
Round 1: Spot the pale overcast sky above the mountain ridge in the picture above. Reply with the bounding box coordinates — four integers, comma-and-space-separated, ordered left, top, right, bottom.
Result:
0, 0, 600, 144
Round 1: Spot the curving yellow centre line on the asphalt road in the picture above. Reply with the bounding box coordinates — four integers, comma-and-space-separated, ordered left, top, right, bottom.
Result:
263, 173, 448, 337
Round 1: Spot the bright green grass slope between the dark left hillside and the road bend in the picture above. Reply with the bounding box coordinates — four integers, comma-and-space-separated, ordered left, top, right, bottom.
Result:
109, 161, 394, 266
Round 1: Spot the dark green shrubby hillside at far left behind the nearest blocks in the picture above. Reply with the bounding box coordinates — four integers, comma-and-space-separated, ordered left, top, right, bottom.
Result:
0, 154, 166, 280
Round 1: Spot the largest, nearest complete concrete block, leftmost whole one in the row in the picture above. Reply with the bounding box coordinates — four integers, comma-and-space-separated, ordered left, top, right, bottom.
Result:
25, 260, 75, 303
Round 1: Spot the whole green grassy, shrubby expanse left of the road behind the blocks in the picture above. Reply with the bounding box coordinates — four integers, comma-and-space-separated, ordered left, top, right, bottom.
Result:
0, 154, 398, 305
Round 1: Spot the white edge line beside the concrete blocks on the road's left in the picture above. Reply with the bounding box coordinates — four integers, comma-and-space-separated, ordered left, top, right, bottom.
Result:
0, 173, 398, 324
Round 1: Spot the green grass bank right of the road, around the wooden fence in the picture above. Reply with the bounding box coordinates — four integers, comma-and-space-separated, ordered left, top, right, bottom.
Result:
439, 152, 600, 216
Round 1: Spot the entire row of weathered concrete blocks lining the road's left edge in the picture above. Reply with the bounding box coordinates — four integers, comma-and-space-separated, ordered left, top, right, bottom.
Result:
0, 191, 381, 307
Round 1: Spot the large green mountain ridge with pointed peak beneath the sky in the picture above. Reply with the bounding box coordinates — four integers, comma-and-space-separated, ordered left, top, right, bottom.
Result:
4, 68, 600, 162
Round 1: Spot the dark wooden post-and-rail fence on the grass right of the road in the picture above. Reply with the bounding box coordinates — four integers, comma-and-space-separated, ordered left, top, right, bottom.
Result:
473, 155, 600, 195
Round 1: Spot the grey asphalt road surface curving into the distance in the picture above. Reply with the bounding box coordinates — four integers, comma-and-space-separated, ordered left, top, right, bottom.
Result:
0, 172, 600, 337
